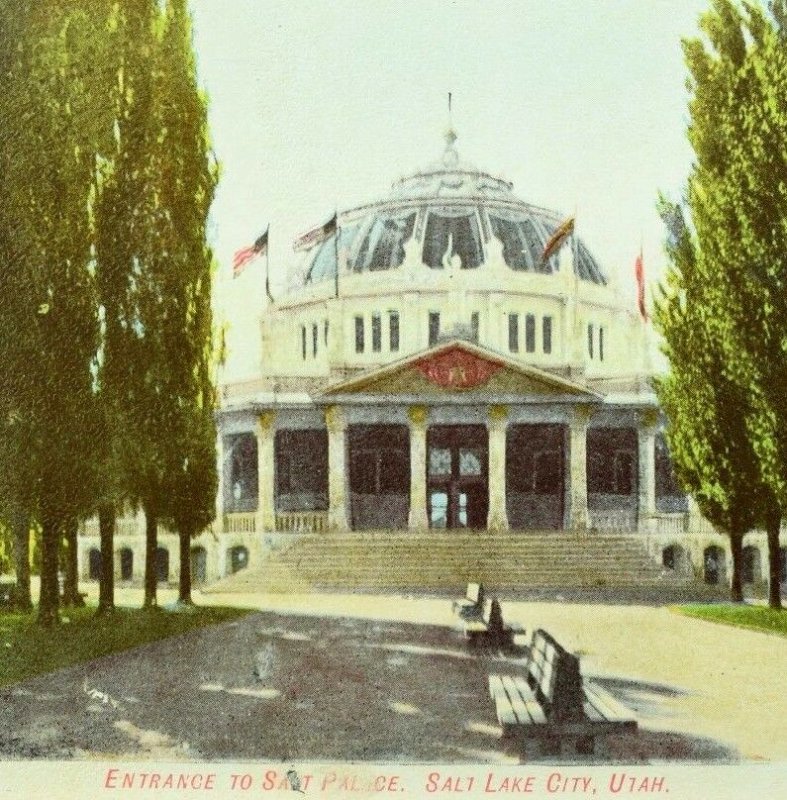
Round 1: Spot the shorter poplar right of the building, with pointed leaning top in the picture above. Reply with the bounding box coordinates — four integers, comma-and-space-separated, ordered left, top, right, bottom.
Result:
655, 200, 777, 601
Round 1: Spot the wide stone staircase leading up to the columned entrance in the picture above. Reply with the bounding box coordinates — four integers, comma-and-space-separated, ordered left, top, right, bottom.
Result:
206, 531, 723, 596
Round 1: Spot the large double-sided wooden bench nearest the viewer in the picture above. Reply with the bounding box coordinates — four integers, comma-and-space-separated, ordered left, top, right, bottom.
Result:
489, 630, 637, 753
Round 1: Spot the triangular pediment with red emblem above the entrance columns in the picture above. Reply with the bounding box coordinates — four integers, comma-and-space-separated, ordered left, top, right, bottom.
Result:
325, 340, 602, 401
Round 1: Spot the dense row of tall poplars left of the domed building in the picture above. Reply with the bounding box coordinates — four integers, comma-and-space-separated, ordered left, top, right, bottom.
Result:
0, 0, 216, 622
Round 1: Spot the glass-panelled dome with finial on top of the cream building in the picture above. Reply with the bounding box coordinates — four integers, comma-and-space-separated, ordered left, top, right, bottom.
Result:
305, 131, 607, 285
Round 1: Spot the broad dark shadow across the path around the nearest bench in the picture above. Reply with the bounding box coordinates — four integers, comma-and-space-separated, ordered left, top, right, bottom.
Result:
0, 613, 735, 764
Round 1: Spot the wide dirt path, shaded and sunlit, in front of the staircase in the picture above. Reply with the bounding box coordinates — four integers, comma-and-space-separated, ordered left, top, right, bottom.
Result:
0, 594, 787, 763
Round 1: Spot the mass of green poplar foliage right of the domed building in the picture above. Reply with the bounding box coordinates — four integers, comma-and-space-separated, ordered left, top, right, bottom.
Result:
660, 0, 787, 605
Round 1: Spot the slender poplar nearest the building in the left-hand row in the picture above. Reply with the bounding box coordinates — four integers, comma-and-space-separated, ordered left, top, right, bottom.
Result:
158, 0, 217, 603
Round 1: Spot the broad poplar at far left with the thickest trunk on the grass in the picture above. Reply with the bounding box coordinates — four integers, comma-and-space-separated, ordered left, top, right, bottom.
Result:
0, 0, 116, 624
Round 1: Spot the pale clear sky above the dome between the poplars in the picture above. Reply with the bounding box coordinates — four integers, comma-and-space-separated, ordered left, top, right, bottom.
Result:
192, 0, 708, 376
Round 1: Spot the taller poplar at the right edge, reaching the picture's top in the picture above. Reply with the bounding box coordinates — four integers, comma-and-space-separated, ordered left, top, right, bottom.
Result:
665, 0, 787, 607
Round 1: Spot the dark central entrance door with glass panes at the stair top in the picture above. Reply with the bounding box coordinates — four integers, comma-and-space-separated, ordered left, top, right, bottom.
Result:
427, 425, 489, 528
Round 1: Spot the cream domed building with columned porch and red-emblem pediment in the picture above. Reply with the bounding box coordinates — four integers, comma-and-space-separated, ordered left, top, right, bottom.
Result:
219, 132, 686, 548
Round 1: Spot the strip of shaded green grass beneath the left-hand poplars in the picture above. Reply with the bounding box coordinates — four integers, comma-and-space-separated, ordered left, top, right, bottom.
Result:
0, 606, 248, 686
